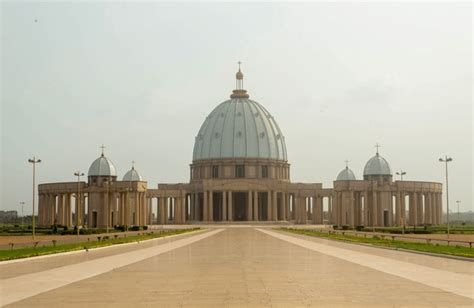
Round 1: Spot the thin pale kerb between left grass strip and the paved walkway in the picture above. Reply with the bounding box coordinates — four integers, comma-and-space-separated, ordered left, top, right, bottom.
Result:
0, 229, 209, 268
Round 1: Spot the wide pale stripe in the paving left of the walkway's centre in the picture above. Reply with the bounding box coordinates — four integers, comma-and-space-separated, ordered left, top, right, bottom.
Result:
0, 229, 224, 306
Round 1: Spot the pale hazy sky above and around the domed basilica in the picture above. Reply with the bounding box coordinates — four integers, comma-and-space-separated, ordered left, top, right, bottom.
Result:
1, 2, 473, 211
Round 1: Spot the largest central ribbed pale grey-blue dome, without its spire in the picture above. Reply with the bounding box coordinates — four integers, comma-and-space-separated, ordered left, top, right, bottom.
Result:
193, 98, 287, 161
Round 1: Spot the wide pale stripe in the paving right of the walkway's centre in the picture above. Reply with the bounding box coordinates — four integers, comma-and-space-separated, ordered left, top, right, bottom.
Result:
257, 228, 474, 299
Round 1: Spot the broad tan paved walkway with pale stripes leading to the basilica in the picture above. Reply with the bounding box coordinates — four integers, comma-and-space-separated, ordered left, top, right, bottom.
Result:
0, 227, 474, 307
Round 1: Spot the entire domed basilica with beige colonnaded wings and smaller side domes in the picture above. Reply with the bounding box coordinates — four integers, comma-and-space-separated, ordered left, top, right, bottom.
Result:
38, 67, 442, 228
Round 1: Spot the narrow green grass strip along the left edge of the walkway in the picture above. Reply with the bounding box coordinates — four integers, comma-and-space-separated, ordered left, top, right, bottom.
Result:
0, 228, 200, 261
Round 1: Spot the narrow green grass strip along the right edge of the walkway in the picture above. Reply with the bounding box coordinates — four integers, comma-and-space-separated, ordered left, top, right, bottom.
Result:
280, 228, 474, 258
